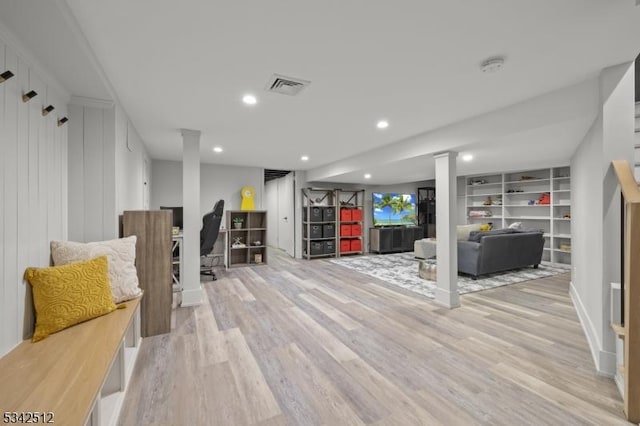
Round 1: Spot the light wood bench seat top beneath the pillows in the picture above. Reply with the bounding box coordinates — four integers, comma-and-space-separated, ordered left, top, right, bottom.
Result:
0, 298, 140, 425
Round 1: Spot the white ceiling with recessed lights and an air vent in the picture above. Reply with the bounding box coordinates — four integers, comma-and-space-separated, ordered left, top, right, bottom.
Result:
0, 0, 640, 183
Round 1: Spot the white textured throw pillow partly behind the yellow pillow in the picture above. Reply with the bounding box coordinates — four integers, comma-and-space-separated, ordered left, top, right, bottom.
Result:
51, 235, 142, 303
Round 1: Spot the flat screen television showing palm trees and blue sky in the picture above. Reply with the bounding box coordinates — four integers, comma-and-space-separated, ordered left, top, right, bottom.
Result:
373, 192, 418, 226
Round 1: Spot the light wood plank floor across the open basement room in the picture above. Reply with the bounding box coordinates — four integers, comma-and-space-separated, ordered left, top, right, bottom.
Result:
120, 253, 626, 426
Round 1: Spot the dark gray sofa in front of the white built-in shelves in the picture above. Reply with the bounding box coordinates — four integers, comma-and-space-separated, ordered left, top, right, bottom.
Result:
458, 228, 544, 278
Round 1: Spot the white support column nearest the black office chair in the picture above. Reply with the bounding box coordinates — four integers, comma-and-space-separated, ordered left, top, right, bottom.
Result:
180, 129, 202, 306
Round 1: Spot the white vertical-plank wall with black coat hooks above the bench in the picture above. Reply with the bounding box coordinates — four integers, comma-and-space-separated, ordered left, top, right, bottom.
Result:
0, 39, 68, 356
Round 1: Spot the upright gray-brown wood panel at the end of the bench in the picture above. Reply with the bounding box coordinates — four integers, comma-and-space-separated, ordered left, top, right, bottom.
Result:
122, 210, 172, 337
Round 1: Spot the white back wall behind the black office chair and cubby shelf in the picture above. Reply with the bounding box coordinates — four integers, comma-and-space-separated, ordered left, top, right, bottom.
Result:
151, 160, 265, 218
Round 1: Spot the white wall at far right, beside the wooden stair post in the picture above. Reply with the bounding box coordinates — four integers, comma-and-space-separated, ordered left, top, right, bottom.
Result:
571, 63, 634, 376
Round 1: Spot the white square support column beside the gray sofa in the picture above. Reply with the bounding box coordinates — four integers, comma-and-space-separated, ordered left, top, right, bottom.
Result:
433, 152, 460, 308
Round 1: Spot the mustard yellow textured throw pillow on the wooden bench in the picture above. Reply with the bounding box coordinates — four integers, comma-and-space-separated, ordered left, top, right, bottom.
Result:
24, 256, 116, 342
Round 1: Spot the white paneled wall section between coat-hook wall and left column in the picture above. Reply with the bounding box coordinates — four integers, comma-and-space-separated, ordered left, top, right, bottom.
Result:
69, 98, 148, 242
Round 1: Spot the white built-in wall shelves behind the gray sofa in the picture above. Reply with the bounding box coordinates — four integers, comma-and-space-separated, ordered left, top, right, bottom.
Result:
465, 166, 571, 264
